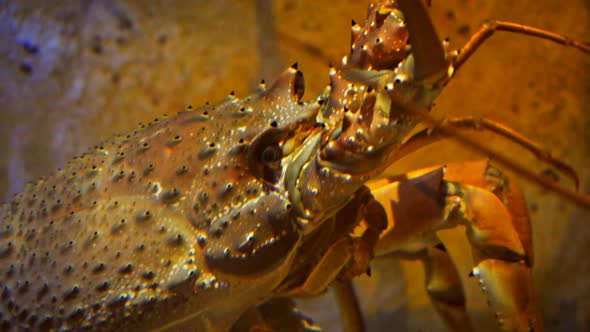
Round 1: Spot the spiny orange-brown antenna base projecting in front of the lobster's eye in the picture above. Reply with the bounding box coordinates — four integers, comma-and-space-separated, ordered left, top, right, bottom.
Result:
287, 0, 454, 228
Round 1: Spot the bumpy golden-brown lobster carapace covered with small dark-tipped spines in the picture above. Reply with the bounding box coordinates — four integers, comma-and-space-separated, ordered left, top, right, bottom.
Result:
0, 68, 315, 329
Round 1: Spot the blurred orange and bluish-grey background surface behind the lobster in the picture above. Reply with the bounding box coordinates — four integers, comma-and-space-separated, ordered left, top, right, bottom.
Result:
0, 0, 590, 331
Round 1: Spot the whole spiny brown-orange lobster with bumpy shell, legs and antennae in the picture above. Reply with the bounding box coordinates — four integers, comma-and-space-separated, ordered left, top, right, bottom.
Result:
0, 0, 589, 330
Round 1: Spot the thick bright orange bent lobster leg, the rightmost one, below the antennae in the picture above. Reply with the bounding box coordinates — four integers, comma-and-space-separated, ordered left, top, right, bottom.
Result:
370, 160, 541, 331
